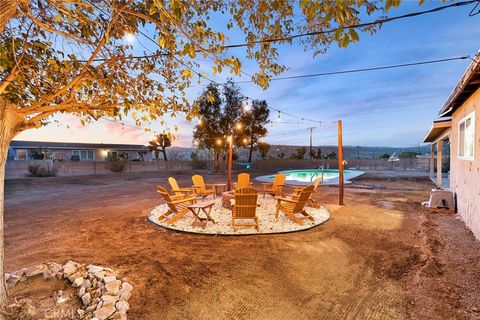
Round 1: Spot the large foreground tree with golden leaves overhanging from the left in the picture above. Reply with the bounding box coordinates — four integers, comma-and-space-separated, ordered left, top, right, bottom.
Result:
0, 0, 410, 310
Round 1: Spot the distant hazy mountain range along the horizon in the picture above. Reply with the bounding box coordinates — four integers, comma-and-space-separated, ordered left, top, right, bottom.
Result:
167, 145, 430, 161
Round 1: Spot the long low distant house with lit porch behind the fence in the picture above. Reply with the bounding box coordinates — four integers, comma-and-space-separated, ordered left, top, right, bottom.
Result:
8, 141, 152, 161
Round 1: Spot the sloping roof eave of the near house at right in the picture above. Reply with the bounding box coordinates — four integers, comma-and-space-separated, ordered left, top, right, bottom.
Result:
438, 50, 480, 118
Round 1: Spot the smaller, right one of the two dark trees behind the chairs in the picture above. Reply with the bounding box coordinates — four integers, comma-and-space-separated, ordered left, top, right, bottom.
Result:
240, 100, 270, 162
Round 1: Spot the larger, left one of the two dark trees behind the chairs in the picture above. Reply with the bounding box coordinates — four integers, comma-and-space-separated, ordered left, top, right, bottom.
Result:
193, 81, 243, 172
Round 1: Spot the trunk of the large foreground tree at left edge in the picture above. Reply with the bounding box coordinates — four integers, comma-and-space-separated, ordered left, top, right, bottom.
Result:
0, 104, 24, 320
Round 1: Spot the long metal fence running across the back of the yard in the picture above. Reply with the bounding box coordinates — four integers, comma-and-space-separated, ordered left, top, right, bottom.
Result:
6, 158, 430, 179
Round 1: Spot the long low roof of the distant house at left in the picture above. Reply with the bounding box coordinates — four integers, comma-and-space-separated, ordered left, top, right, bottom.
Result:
10, 140, 144, 150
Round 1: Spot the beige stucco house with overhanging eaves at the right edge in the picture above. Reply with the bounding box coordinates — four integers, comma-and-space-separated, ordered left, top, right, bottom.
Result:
425, 51, 480, 239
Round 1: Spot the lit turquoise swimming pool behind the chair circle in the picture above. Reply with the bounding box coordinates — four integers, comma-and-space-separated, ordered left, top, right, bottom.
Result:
255, 169, 364, 185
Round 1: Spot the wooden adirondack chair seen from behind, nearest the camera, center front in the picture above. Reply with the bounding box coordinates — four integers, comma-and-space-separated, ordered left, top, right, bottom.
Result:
232, 187, 260, 231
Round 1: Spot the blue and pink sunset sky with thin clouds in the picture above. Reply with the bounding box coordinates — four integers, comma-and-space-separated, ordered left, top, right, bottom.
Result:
15, 1, 480, 147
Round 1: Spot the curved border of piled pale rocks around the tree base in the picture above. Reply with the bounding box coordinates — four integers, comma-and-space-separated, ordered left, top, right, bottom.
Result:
5, 261, 133, 320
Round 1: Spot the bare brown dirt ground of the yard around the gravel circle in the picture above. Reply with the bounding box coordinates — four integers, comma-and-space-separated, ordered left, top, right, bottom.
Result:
5, 173, 480, 319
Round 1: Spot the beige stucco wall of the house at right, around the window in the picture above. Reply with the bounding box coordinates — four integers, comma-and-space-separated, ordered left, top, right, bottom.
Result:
450, 89, 480, 239
